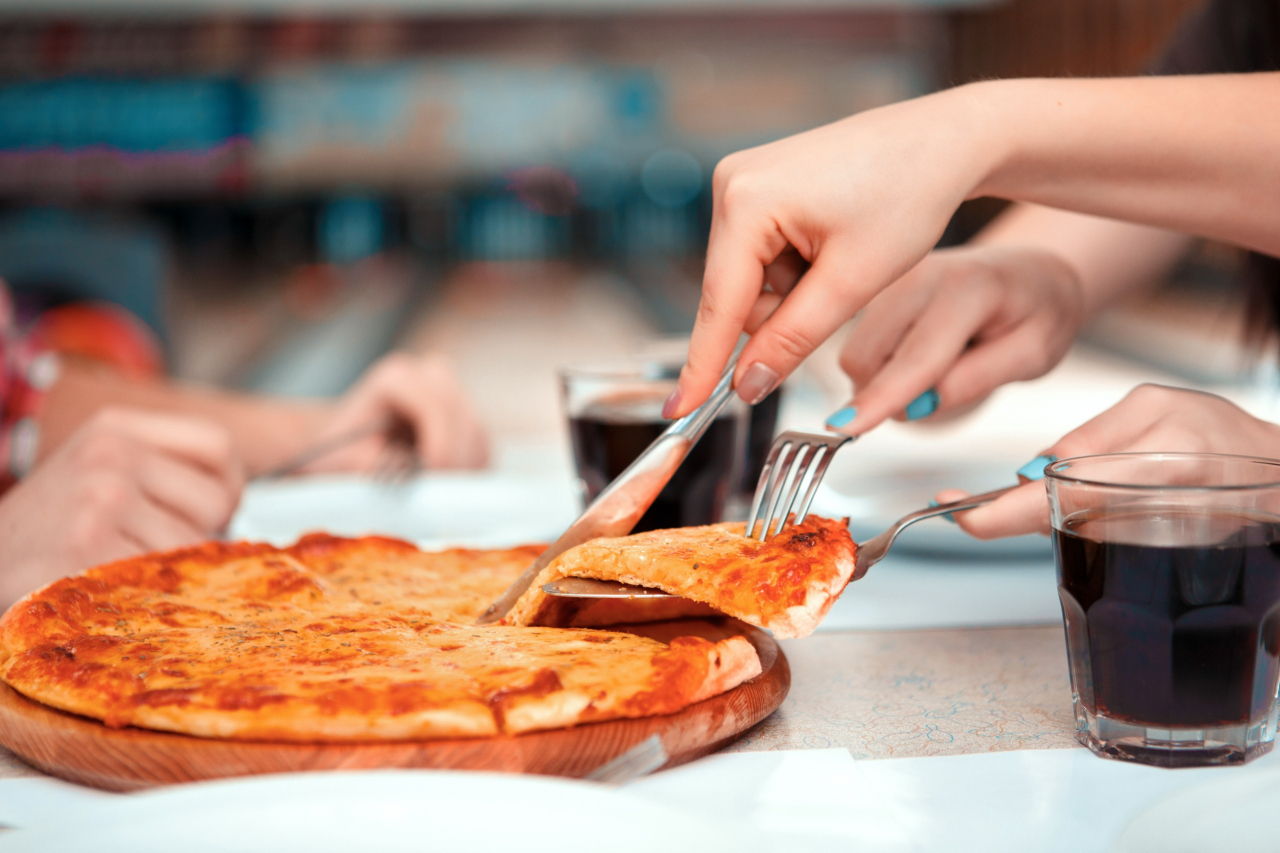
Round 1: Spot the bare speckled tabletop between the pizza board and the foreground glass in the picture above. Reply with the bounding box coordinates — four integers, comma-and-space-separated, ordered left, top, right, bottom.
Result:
0, 625, 1075, 779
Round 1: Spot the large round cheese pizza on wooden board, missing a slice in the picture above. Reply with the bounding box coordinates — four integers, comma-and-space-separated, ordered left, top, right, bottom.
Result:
0, 534, 760, 742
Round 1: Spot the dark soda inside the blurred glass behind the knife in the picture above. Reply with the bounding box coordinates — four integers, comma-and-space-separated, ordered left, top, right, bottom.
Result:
568, 402, 740, 533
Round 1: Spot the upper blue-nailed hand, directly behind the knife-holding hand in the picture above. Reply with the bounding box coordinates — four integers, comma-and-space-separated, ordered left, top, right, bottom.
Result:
828, 246, 1084, 435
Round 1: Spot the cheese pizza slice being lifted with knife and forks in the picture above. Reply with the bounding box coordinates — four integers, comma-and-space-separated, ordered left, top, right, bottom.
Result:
503, 516, 856, 638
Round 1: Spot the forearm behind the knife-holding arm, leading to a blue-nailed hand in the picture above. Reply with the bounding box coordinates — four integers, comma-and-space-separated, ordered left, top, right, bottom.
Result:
973, 204, 1192, 318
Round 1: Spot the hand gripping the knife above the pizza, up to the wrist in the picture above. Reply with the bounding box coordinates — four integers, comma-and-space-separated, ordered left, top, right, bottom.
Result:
664, 86, 997, 416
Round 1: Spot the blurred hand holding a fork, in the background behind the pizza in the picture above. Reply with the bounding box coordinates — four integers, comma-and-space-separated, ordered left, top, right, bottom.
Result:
308, 352, 489, 471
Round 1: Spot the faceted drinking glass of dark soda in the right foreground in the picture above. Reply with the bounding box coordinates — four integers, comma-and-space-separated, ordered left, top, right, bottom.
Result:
1044, 453, 1280, 767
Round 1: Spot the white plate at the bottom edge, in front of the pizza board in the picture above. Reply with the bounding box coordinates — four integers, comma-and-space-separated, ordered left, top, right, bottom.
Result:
0, 771, 760, 853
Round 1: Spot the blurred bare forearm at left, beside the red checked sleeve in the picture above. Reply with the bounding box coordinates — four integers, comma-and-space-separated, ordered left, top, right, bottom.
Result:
38, 359, 329, 475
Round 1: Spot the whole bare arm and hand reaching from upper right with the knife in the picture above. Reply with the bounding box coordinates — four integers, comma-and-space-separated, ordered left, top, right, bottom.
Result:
668, 73, 1280, 415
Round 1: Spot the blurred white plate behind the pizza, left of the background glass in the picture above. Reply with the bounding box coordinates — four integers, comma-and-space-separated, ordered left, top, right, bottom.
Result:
230, 473, 579, 547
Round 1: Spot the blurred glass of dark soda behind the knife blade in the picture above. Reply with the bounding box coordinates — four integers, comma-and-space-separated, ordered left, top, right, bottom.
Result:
559, 359, 748, 533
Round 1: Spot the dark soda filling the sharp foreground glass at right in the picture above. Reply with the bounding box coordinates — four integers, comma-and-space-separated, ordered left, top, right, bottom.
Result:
1053, 507, 1280, 729
